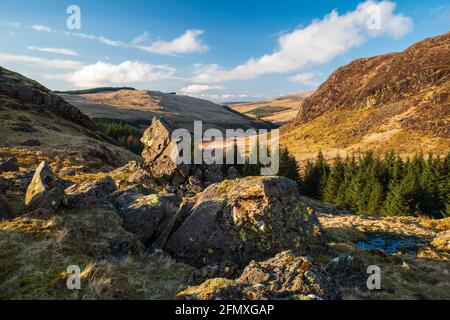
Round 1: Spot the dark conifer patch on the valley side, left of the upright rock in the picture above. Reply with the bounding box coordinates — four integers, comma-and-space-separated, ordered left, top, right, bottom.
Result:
94, 119, 143, 154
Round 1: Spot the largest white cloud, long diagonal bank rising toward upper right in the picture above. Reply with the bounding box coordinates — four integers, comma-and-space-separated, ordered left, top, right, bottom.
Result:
192, 0, 412, 83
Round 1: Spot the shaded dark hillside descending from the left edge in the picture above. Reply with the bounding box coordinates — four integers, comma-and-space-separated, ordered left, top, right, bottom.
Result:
0, 67, 136, 168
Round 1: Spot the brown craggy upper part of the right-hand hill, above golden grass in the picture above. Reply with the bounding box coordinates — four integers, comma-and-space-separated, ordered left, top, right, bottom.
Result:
288, 33, 450, 138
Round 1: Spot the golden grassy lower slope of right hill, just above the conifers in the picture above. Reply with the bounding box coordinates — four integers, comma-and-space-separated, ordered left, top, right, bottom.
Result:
281, 108, 450, 162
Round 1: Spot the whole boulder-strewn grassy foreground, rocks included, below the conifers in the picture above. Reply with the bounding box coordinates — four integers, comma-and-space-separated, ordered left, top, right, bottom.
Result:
0, 118, 450, 299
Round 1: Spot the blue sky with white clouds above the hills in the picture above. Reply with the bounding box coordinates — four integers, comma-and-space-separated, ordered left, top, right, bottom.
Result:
0, 0, 450, 101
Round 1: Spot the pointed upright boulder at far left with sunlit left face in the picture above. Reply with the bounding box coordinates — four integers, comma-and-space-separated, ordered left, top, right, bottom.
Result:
25, 161, 64, 211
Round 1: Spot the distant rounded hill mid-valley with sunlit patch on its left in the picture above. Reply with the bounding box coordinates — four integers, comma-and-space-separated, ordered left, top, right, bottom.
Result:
61, 89, 272, 130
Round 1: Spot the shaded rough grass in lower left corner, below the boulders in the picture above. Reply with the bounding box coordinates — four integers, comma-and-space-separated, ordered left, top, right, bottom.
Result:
0, 208, 193, 299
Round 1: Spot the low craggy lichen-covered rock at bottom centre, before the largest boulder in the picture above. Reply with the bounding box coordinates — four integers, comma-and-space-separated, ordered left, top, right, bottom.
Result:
178, 251, 339, 300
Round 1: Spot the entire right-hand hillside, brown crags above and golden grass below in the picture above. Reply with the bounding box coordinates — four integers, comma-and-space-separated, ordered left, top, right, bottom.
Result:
283, 33, 450, 159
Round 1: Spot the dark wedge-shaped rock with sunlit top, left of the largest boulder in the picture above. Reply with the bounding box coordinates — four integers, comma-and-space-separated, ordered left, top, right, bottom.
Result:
114, 190, 177, 244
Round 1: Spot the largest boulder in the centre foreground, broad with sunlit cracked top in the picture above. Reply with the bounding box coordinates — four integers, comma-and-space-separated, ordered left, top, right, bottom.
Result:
166, 177, 318, 266
